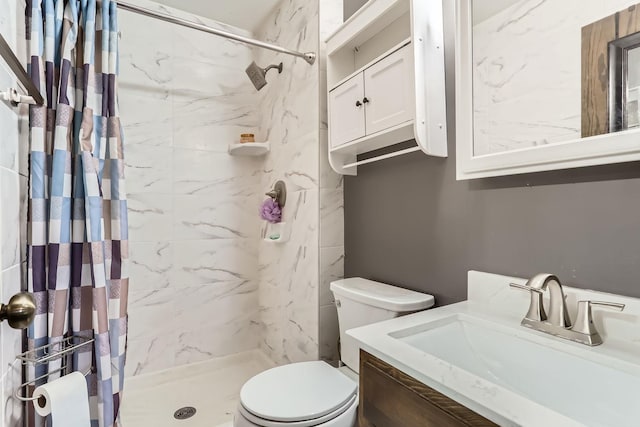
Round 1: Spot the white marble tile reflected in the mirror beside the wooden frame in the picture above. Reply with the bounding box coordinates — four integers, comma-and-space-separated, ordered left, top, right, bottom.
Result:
473, 0, 637, 155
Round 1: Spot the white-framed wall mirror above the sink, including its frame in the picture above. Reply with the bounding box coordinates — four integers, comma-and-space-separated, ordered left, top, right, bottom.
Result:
456, 0, 640, 179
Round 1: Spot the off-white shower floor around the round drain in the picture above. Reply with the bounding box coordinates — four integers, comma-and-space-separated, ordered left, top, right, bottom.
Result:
121, 350, 275, 427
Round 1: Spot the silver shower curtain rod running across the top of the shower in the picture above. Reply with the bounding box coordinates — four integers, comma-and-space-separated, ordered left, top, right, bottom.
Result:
118, 1, 316, 65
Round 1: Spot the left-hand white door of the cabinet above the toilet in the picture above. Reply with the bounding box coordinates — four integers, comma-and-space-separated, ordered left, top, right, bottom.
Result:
329, 73, 364, 147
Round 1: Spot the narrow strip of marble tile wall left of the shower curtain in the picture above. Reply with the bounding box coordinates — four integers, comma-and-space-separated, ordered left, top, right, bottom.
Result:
0, 0, 28, 427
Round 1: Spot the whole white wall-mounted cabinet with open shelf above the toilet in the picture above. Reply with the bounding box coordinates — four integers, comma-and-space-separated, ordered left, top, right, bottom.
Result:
327, 0, 447, 175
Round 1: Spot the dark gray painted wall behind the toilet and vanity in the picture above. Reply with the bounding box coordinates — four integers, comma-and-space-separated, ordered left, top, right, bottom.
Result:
344, 0, 640, 305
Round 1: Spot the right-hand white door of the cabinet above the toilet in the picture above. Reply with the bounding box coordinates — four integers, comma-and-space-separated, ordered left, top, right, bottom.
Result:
364, 45, 415, 135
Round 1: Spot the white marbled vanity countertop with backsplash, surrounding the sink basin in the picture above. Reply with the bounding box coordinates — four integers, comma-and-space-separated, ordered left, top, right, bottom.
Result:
347, 271, 640, 427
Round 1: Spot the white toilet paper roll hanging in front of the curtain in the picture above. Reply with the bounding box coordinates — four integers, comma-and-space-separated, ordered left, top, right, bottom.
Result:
33, 372, 91, 427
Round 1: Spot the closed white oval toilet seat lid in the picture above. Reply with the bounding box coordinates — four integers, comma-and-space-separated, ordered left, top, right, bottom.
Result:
240, 361, 358, 422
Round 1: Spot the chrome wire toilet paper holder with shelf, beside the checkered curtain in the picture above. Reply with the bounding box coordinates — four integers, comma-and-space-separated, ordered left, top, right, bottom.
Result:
14, 335, 95, 406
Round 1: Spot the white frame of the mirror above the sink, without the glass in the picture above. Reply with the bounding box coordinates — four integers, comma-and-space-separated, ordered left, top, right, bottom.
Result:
455, 0, 640, 180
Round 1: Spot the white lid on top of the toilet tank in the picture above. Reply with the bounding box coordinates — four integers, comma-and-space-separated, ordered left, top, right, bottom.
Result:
330, 277, 435, 313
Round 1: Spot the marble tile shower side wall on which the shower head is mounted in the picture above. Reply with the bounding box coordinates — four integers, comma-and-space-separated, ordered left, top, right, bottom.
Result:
256, 0, 320, 363
